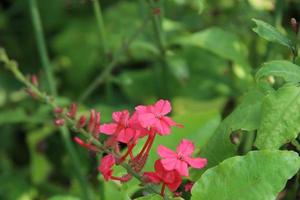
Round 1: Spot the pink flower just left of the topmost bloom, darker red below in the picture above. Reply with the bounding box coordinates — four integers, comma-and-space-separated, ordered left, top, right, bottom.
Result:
100, 110, 135, 144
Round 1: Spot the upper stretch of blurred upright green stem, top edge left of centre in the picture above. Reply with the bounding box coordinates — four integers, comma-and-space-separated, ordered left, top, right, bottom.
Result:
92, 0, 108, 57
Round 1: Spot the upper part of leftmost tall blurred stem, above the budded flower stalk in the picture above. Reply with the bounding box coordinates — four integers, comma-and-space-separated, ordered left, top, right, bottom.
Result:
29, 0, 56, 96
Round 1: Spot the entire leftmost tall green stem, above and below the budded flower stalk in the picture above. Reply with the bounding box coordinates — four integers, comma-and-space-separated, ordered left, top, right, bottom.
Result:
25, 0, 91, 199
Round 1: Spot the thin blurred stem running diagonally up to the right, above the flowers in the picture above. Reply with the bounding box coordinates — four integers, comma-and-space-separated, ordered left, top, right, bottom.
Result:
78, 18, 149, 102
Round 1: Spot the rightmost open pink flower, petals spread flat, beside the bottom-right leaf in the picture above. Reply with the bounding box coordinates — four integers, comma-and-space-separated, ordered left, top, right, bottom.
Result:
157, 139, 207, 176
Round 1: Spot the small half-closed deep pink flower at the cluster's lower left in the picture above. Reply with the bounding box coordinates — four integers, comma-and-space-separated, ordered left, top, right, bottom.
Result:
98, 154, 116, 181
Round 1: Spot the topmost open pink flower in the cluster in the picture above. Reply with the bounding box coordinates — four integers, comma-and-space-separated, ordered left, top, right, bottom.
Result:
135, 99, 180, 135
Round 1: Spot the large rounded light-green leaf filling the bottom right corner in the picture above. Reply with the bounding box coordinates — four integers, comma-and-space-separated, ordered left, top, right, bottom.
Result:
191, 150, 300, 200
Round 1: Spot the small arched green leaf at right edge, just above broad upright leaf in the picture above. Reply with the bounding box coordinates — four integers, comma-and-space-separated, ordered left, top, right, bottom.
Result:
256, 60, 300, 82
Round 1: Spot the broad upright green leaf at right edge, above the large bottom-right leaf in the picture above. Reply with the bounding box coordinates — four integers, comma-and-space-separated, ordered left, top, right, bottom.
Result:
255, 85, 300, 149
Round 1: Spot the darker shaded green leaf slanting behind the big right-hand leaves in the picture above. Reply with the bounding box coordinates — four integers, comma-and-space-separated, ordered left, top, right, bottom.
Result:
198, 89, 264, 176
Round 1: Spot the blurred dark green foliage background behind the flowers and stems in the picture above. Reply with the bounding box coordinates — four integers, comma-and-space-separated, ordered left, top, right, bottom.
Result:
0, 0, 300, 200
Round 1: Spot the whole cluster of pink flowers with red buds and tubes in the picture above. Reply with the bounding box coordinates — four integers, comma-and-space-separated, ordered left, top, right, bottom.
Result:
55, 100, 207, 195
